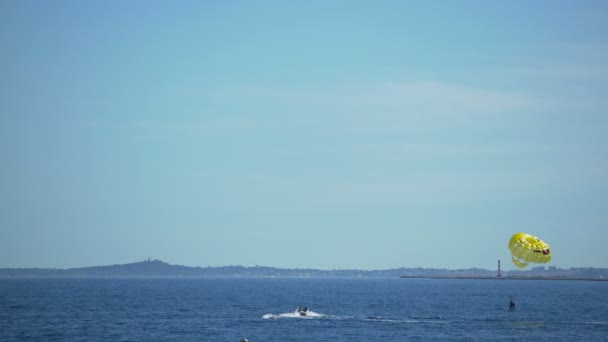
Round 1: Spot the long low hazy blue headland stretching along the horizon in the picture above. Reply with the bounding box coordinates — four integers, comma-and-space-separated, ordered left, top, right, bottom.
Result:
0, 259, 608, 281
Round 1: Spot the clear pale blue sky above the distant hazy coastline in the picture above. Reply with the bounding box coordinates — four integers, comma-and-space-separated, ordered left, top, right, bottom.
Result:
0, 1, 608, 269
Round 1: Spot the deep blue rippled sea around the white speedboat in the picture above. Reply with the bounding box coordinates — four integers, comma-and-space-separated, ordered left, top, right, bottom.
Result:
0, 278, 608, 342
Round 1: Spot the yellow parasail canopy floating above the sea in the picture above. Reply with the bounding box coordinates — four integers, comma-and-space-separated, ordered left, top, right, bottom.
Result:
509, 233, 551, 268
